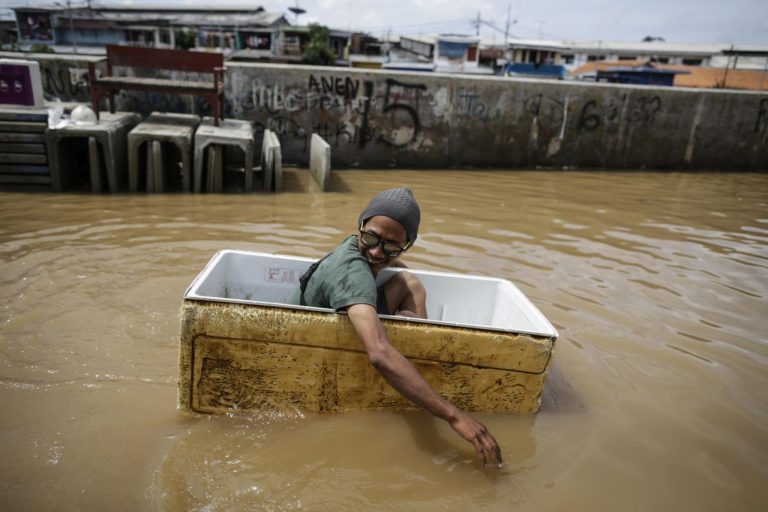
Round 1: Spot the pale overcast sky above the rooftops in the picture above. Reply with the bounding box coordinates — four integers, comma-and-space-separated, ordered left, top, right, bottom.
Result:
0, 0, 768, 45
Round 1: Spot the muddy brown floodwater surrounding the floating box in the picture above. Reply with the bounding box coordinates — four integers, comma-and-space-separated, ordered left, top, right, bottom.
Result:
0, 170, 768, 512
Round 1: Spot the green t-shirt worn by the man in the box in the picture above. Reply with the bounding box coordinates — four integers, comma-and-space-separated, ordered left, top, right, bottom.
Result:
288, 235, 377, 311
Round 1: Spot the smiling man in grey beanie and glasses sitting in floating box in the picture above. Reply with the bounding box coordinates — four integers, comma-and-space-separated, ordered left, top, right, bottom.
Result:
289, 188, 503, 468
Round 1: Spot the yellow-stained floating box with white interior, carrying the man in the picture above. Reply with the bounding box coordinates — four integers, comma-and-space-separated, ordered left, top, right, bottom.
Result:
178, 251, 557, 413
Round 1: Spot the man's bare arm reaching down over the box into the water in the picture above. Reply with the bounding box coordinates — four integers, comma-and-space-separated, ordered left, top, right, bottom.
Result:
347, 304, 503, 468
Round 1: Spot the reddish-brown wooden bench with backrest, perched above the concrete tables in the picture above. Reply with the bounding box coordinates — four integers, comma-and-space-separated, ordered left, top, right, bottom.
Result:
88, 45, 224, 126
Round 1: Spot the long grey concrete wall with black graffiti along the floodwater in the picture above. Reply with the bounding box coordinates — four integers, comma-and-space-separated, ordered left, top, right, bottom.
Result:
7, 54, 768, 170
